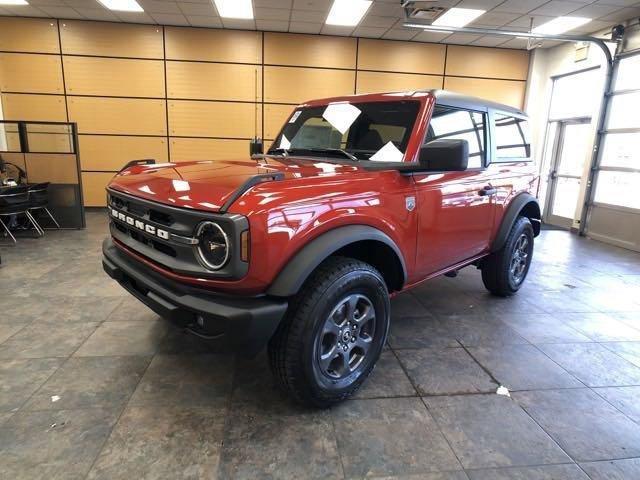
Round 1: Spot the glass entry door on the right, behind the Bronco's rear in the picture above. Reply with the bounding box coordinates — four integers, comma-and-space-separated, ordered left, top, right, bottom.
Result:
544, 118, 591, 228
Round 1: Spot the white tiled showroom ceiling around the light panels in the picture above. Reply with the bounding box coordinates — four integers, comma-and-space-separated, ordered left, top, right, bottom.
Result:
0, 0, 640, 48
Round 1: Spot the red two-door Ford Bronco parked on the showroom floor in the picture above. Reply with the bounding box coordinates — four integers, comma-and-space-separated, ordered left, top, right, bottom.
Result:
103, 90, 540, 407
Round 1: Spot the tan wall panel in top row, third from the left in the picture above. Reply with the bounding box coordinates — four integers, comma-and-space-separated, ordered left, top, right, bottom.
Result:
165, 27, 262, 63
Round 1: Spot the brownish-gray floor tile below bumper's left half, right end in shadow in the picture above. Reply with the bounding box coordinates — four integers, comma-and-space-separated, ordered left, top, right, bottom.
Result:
75, 320, 168, 357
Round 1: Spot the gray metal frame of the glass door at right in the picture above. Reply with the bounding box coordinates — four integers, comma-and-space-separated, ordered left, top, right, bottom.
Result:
542, 117, 591, 229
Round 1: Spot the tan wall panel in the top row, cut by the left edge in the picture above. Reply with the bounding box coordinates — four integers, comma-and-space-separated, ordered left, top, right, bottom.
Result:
0, 17, 60, 53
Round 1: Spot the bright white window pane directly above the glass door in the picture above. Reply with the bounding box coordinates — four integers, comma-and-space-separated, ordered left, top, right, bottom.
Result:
549, 68, 603, 120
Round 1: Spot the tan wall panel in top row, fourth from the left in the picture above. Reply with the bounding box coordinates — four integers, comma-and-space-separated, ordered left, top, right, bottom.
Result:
264, 32, 356, 69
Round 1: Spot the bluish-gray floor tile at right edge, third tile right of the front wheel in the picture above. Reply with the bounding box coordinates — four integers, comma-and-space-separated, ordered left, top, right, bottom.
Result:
538, 343, 640, 387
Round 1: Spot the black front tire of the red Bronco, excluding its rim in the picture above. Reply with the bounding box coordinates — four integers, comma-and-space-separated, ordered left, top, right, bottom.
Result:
268, 257, 390, 408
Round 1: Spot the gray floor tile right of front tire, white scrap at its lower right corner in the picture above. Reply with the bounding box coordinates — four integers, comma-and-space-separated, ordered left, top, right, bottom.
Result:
397, 348, 498, 395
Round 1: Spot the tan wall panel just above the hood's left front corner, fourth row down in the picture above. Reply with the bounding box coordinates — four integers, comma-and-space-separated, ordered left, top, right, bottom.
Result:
78, 135, 168, 171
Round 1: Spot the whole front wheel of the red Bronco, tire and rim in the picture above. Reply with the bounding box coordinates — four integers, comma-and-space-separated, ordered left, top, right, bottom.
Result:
269, 257, 390, 408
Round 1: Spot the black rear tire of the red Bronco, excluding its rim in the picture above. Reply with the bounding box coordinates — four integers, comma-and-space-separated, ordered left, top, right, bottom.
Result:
481, 217, 534, 297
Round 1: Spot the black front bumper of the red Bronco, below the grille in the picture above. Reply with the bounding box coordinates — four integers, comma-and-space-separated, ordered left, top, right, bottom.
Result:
102, 238, 288, 356
